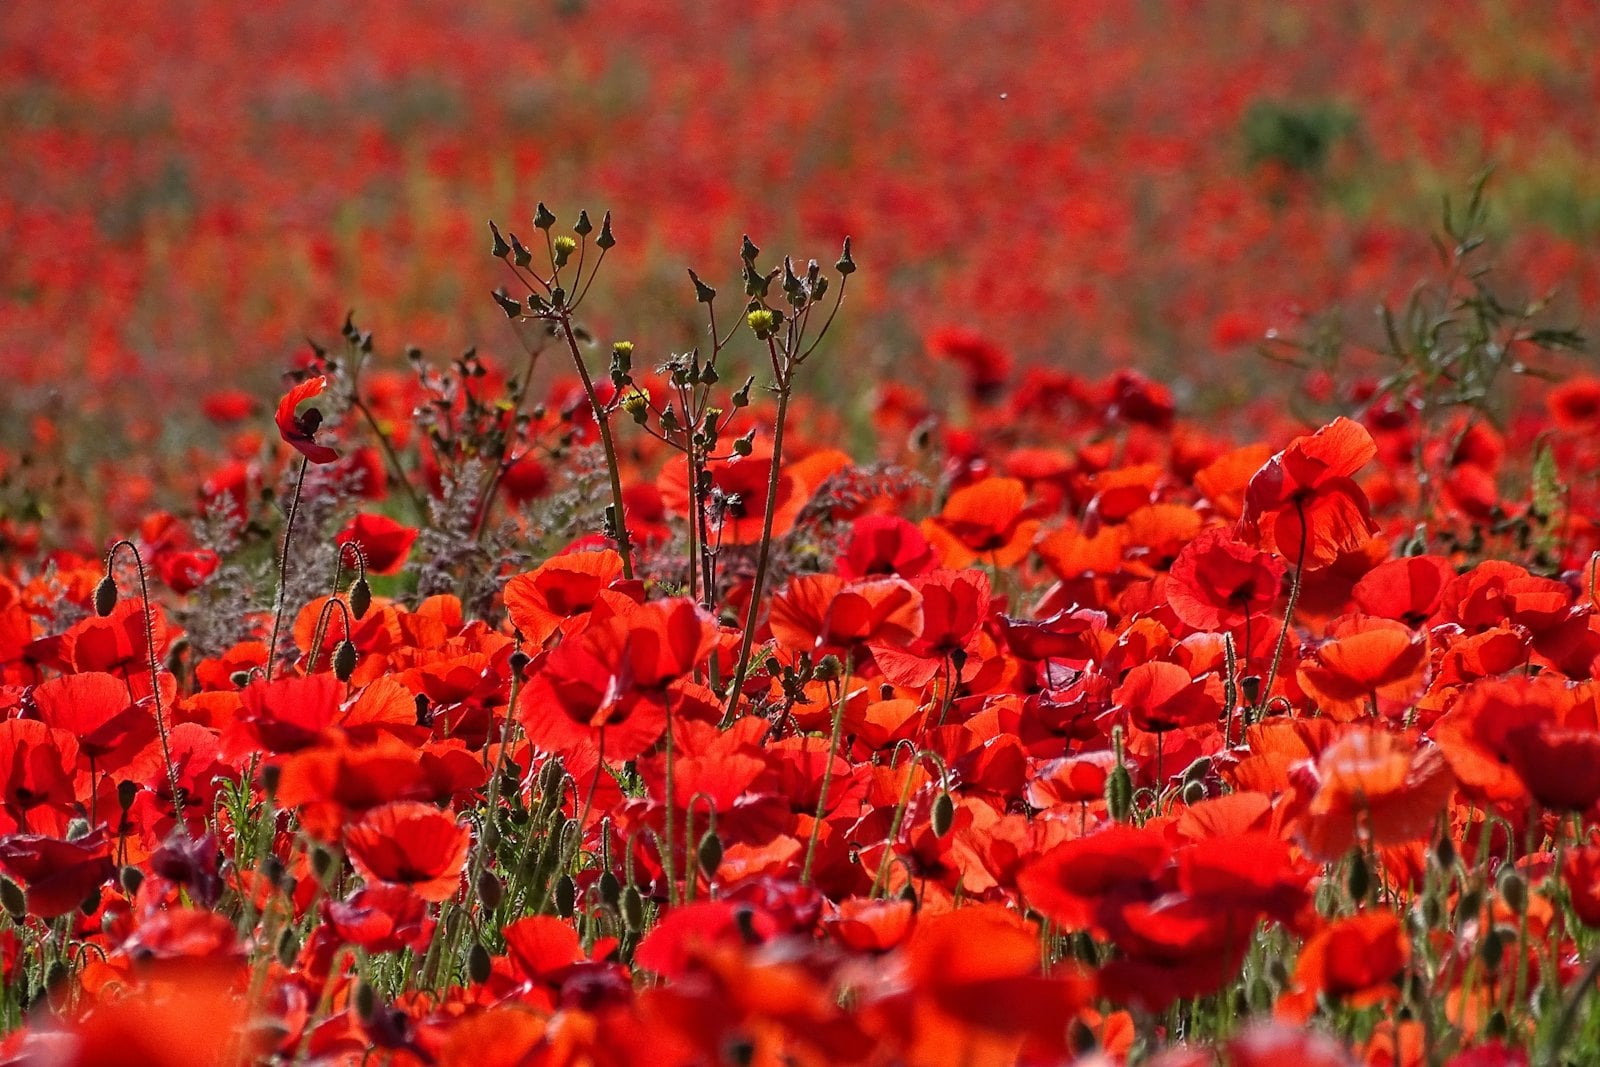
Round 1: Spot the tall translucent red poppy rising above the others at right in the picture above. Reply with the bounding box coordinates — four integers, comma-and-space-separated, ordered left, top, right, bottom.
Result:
1240, 419, 1378, 569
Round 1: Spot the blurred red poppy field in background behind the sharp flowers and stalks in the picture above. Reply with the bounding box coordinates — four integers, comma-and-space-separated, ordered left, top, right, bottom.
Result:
0, 0, 1600, 534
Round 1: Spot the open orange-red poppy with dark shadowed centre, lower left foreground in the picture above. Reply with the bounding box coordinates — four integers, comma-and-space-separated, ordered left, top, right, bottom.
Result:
344, 800, 472, 902
